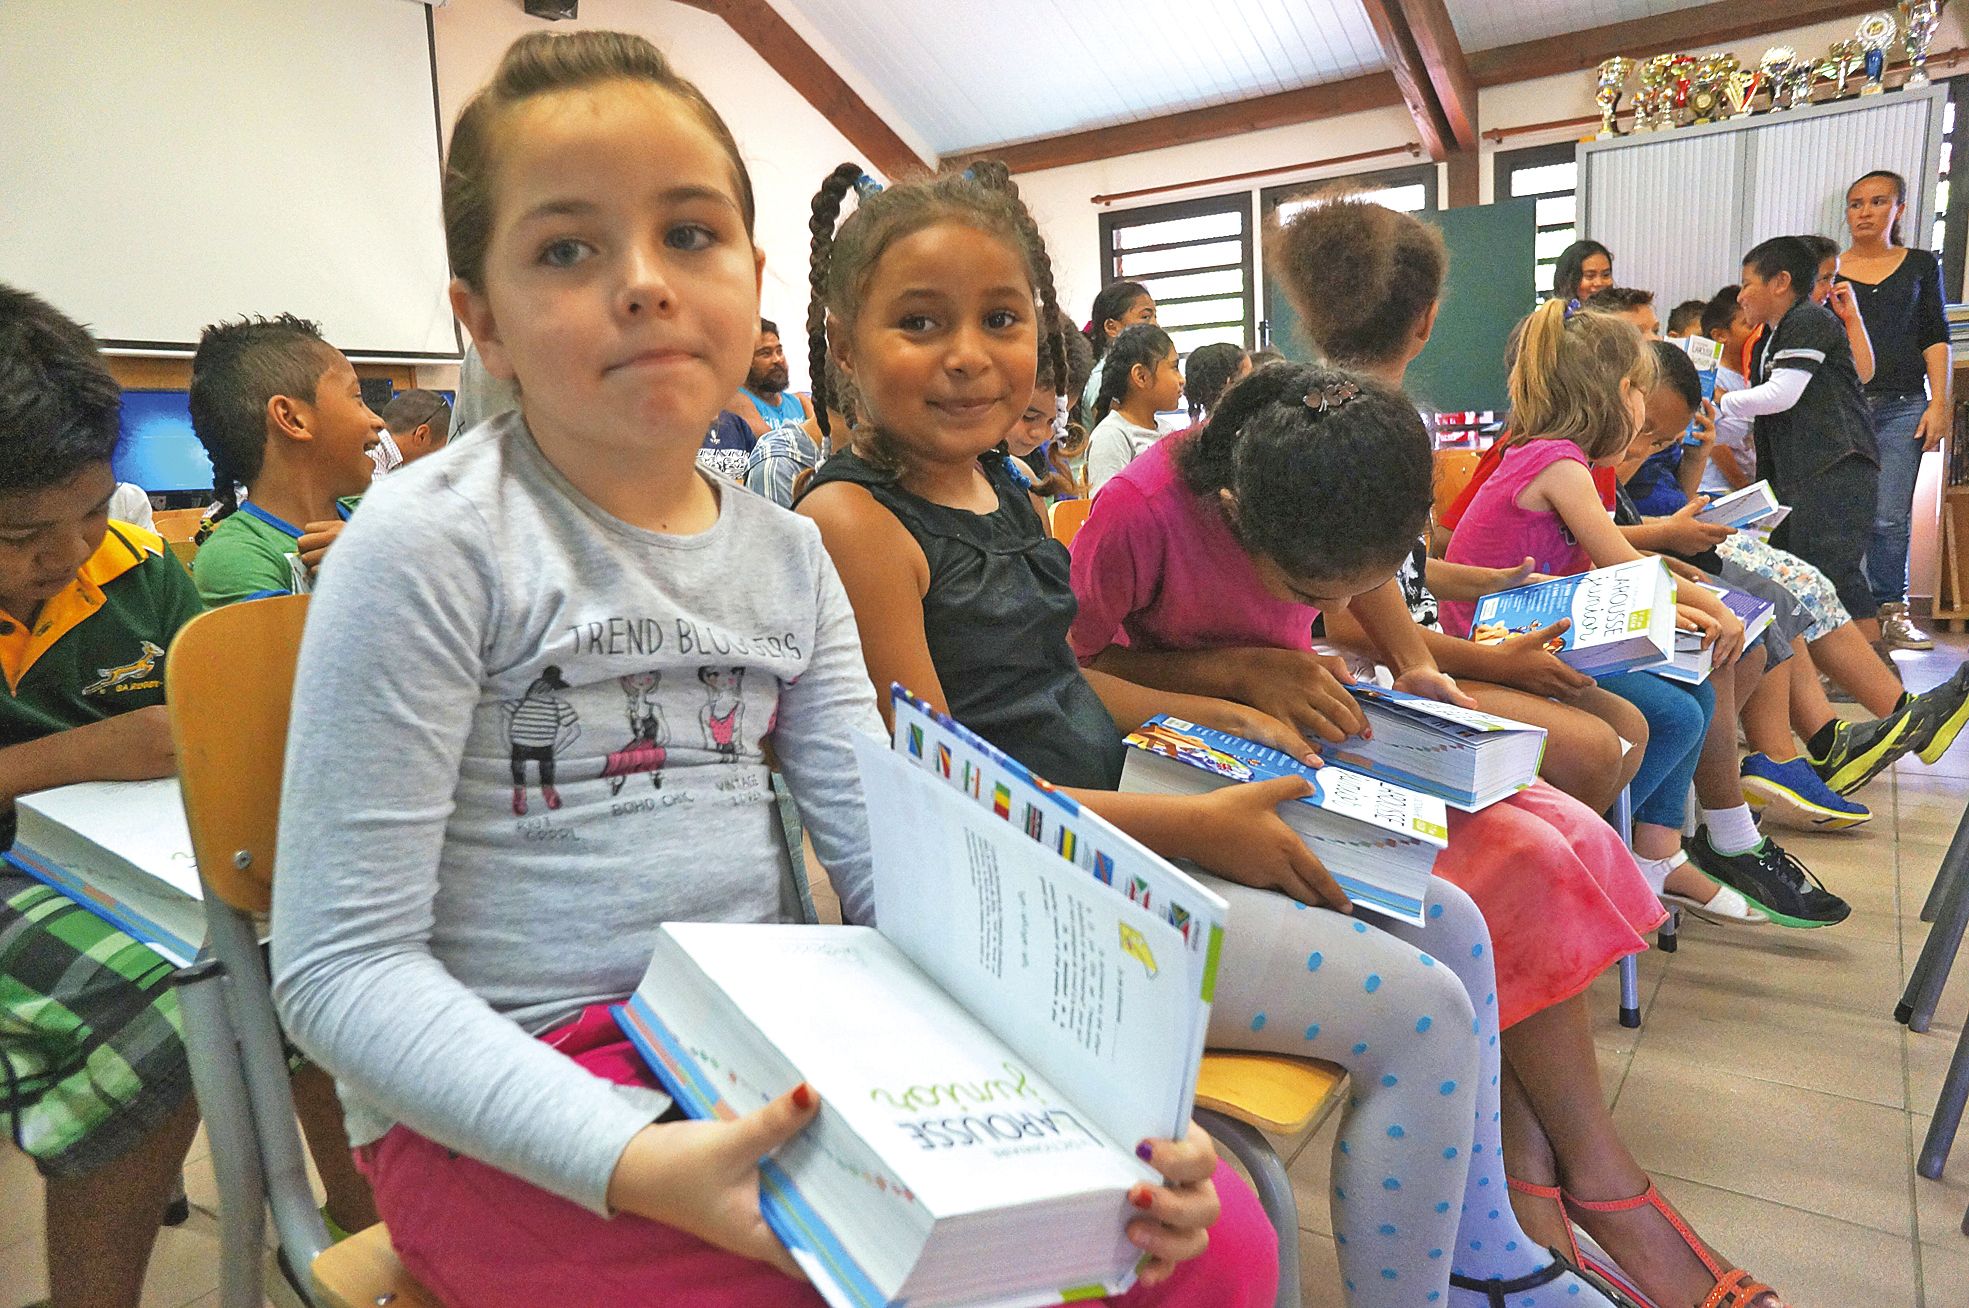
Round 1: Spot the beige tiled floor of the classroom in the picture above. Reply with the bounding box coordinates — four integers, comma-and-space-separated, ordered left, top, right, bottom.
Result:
0, 636, 1969, 1308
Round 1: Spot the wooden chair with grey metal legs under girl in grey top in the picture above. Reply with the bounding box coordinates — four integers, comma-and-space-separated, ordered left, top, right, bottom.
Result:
165, 595, 437, 1308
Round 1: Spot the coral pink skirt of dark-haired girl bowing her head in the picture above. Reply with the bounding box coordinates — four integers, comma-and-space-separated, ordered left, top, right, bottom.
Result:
1435, 782, 1668, 1026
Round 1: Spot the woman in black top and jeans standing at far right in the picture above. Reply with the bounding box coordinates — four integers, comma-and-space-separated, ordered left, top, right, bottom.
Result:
1839, 171, 1951, 650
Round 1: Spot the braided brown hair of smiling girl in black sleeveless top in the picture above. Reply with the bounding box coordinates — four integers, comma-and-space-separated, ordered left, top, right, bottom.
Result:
807, 160, 1067, 463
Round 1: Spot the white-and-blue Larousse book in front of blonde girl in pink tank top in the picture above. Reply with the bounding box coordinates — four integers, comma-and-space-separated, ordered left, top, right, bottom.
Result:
1471, 557, 1676, 676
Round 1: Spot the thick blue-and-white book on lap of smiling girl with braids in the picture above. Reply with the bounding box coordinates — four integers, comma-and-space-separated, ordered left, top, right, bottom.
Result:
1120, 713, 1449, 926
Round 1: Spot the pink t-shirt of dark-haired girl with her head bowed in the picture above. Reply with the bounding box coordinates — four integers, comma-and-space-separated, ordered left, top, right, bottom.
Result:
1067, 435, 1319, 664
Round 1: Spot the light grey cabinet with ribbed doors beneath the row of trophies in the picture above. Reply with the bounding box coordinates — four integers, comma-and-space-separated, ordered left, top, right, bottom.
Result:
1579, 85, 1947, 317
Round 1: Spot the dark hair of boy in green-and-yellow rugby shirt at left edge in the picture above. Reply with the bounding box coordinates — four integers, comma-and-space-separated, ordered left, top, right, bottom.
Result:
0, 286, 122, 494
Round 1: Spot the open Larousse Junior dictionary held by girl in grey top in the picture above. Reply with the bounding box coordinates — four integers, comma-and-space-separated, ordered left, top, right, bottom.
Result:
618, 689, 1225, 1308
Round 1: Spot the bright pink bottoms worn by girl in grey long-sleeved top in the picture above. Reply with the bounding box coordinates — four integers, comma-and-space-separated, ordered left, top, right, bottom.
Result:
354, 1005, 1278, 1308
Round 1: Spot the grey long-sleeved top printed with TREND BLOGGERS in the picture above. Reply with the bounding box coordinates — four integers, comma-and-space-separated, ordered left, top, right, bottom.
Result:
272, 414, 882, 1211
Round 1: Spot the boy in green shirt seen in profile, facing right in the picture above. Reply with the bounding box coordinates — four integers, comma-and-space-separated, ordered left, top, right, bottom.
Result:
191, 313, 384, 607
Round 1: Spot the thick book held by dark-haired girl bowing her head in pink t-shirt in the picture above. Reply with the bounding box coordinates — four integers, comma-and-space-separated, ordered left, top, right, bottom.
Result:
1319, 682, 1546, 814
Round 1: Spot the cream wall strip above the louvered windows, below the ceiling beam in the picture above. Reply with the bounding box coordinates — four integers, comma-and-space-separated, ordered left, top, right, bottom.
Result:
1018, 8, 1969, 321
